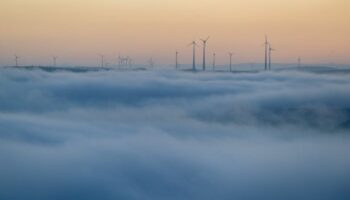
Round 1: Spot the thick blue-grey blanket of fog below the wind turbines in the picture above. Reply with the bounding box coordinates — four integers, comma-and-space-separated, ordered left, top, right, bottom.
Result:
0, 69, 350, 200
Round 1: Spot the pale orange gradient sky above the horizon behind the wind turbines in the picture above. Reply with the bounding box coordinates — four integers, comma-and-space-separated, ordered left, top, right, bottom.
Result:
0, 0, 350, 65
